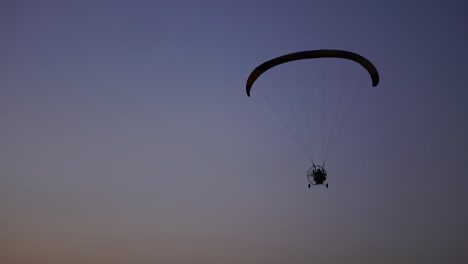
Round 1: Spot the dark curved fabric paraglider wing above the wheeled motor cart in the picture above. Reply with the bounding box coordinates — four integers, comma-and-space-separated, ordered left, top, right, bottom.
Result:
246, 49, 379, 97
